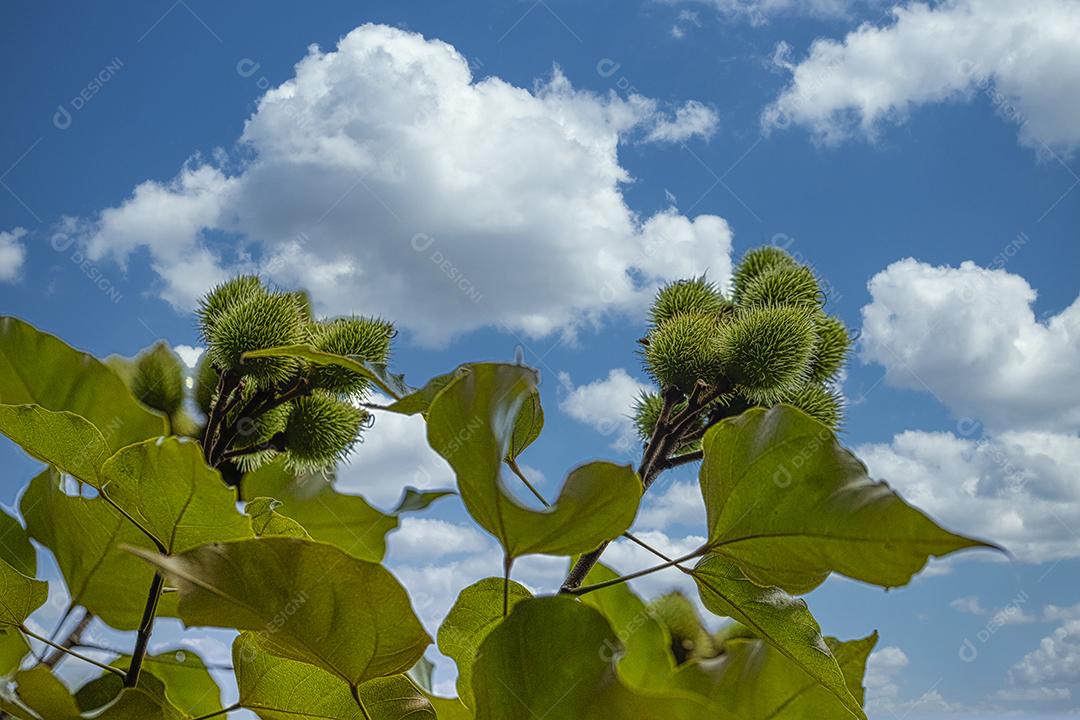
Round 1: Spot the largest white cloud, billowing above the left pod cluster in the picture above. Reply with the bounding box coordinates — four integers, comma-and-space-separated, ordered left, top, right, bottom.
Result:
71, 25, 731, 344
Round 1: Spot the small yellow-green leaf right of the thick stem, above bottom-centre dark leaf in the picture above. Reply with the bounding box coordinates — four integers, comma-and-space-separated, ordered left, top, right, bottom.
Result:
581, 562, 675, 690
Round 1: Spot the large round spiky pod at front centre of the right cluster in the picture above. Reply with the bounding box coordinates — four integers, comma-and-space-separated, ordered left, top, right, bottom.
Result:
716, 305, 816, 404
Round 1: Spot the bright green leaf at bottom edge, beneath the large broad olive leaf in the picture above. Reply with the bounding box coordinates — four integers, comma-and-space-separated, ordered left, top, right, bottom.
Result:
232, 633, 436, 720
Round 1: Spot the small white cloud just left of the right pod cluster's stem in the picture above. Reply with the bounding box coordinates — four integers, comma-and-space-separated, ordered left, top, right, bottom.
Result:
558, 367, 651, 451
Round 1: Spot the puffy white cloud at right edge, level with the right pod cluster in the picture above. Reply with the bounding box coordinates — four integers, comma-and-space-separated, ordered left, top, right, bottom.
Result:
861, 257, 1080, 433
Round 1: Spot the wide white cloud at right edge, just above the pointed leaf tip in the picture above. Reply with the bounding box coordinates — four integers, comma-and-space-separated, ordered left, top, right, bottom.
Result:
855, 431, 1080, 562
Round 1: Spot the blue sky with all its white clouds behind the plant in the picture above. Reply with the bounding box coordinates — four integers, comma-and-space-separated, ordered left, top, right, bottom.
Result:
0, 0, 1080, 718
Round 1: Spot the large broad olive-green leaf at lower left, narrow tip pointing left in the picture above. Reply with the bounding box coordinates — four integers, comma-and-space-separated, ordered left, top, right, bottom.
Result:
132, 538, 431, 685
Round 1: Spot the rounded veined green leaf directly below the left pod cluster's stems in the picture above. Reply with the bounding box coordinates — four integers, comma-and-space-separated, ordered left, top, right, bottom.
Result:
100, 437, 254, 554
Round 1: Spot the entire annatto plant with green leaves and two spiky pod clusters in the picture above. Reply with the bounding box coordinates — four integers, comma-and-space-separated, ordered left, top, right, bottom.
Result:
0, 247, 988, 720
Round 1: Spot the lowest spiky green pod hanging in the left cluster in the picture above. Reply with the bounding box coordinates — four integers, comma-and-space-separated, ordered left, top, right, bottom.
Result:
285, 394, 368, 473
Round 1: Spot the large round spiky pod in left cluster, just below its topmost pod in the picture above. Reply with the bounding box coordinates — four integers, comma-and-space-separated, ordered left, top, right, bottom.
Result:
206, 295, 302, 386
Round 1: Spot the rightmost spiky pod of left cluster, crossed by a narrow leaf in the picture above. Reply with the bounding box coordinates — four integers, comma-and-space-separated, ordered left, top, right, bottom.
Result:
309, 317, 394, 397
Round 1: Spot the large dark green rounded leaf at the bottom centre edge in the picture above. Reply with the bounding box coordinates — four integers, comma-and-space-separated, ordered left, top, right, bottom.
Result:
472, 597, 725, 720
